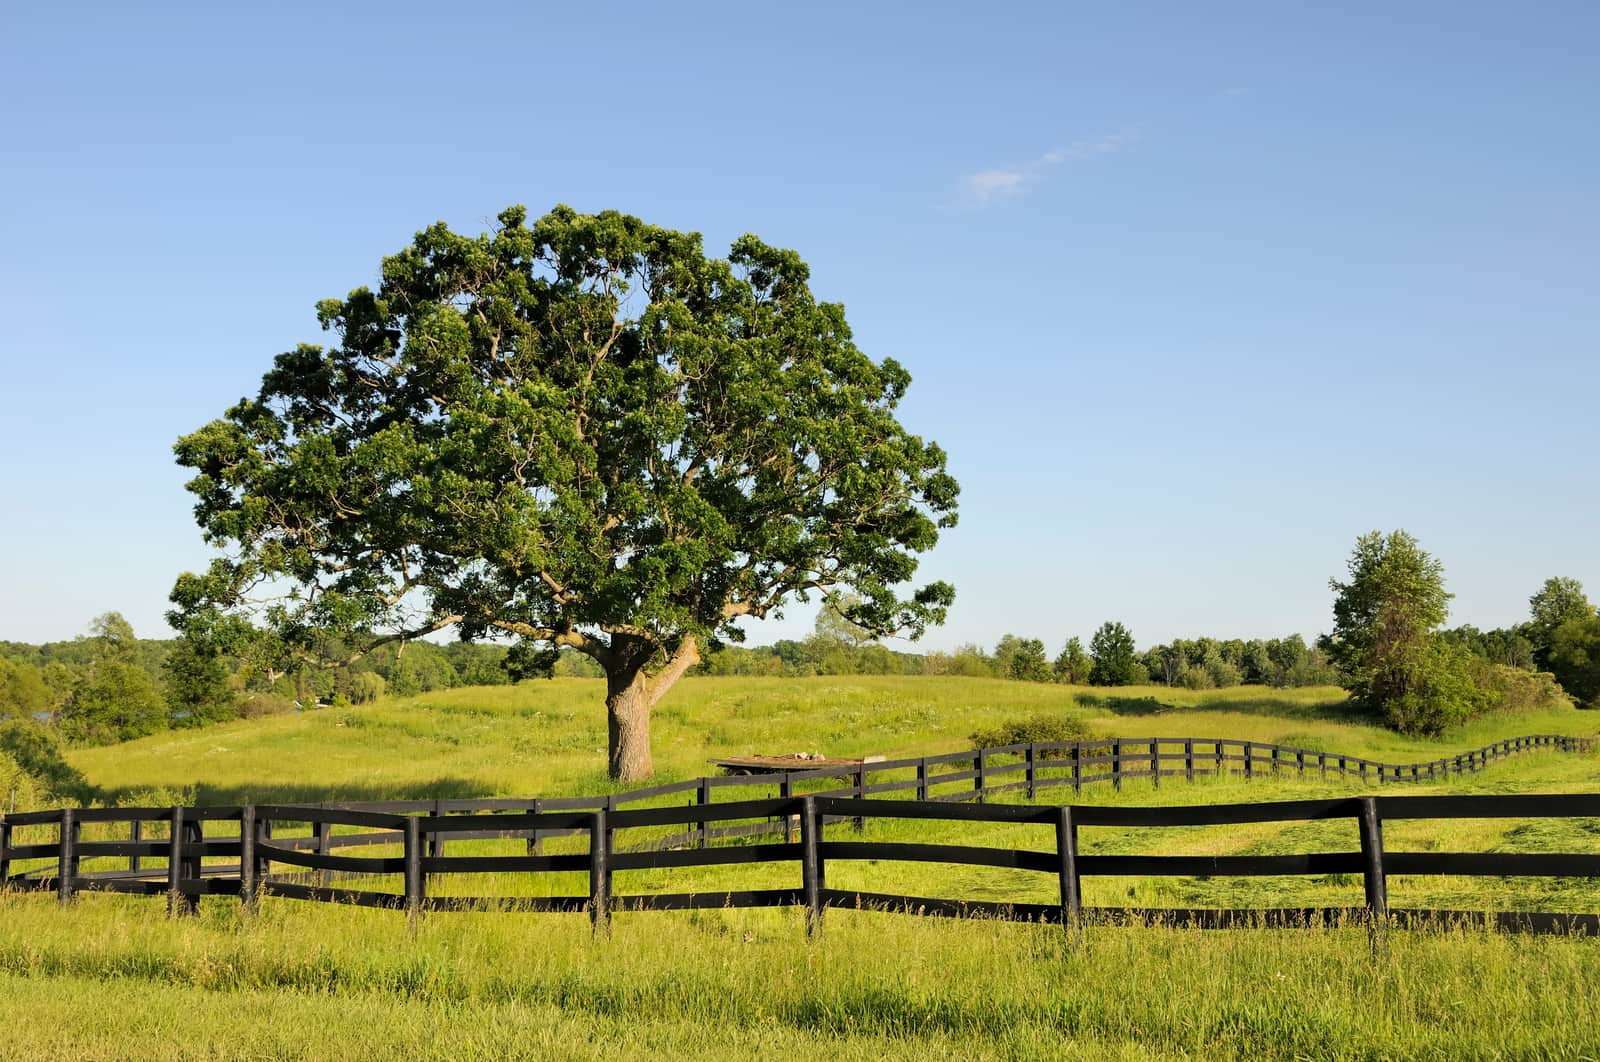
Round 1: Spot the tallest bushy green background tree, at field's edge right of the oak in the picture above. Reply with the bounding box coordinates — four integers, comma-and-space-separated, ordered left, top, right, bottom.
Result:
1325, 531, 1454, 713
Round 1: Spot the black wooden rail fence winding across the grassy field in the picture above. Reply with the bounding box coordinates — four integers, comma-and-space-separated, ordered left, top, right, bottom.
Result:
0, 736, 1600, 932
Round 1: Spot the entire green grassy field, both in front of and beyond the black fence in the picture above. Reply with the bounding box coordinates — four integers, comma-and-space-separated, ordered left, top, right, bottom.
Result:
12, 678, 1600, 1059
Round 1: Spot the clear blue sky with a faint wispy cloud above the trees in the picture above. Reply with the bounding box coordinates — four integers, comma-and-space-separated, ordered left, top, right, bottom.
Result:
0, 2, 1600, 651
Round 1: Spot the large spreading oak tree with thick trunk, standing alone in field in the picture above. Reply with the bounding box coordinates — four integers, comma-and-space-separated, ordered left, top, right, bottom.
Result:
173, 206, 957, 779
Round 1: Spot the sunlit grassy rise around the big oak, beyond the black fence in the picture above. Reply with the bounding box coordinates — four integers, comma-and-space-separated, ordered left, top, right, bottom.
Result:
70, 677, 1600, 803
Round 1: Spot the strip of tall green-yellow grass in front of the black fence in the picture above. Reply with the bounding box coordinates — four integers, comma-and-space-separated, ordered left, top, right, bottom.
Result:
0, 897, 1600, 1059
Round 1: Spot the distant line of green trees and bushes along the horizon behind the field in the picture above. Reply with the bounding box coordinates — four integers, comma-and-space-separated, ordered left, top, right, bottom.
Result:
0, 559, 1600, 758
